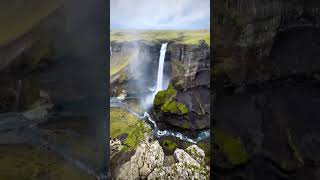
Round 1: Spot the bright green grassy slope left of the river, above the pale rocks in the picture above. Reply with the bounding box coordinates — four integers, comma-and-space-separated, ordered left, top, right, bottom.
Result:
110, 108, 150, 150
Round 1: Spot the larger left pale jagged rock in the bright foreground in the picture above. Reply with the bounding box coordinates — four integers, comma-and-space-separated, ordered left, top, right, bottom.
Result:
116, 141, 164, 180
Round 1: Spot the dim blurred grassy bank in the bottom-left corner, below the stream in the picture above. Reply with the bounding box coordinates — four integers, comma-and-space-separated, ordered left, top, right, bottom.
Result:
0, 144, 95, 180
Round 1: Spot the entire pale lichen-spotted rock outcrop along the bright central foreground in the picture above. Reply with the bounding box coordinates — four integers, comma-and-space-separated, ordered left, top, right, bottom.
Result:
115, 141, 210, 180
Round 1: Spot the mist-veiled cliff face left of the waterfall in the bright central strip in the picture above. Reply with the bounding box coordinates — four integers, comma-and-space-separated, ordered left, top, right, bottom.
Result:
110, 41, 166, 96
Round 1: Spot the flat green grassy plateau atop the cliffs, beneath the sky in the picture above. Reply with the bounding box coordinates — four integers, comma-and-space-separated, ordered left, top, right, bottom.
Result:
110, 30, 210, 45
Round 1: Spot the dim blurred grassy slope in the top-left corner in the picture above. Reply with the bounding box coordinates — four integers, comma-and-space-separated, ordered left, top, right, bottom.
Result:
0, 0, 63, 45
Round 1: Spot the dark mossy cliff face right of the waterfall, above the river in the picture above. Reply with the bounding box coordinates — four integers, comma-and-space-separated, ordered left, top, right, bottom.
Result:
154, 42, 210, 130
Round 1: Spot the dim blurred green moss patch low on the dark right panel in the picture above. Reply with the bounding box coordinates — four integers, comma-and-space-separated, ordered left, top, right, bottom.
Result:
214, 130, 247, 165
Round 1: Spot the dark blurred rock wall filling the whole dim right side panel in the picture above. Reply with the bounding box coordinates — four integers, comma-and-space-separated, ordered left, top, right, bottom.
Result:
211, 0, 320, 180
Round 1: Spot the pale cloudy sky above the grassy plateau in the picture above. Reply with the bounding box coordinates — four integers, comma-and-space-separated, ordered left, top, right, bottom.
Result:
110, 0, 210, 29
